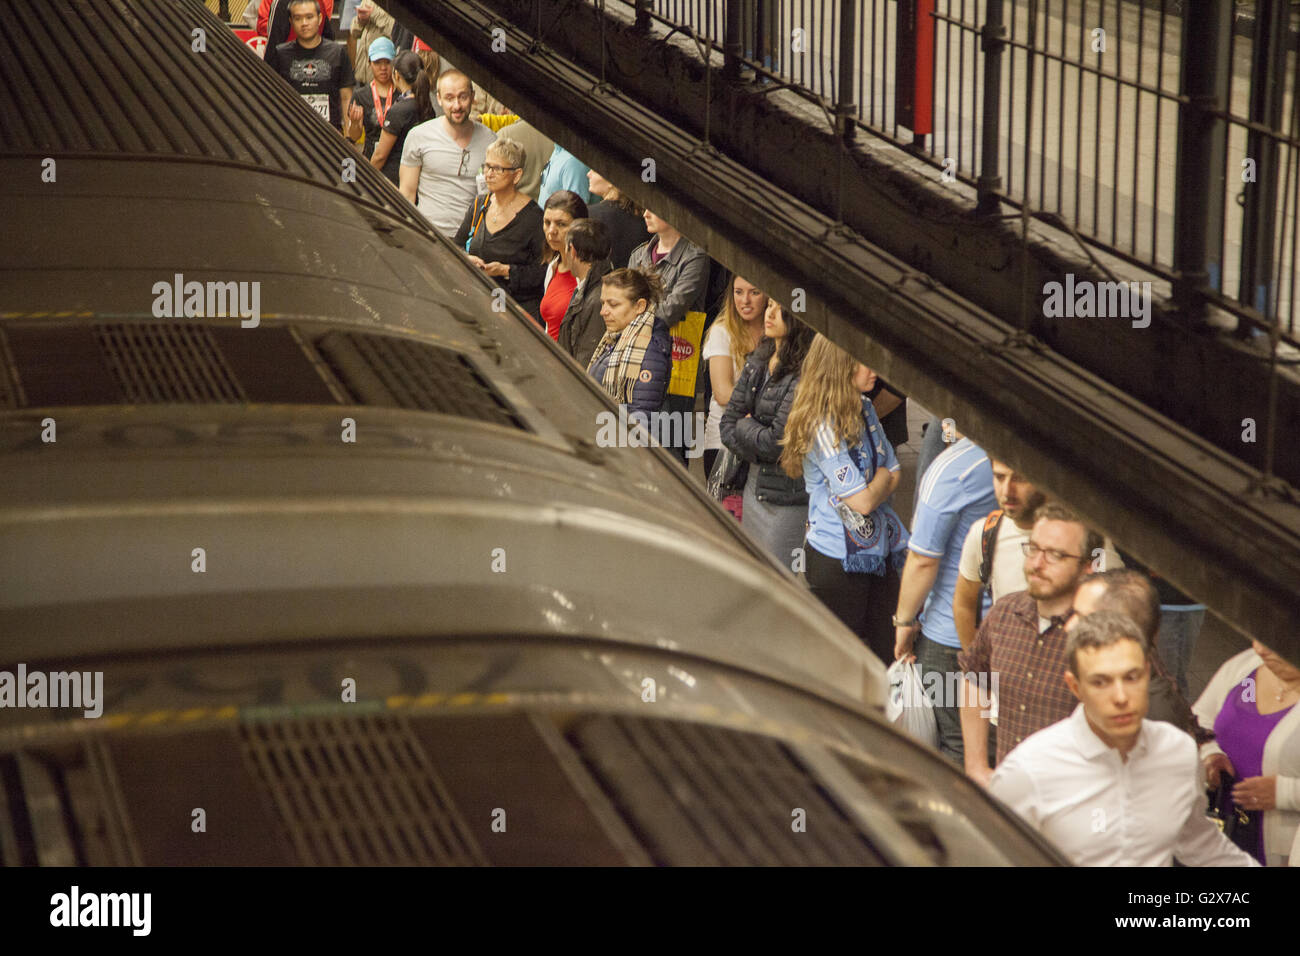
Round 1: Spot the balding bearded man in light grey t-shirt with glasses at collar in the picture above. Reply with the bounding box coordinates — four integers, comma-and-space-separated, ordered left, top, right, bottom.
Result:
398, 70, 497, 238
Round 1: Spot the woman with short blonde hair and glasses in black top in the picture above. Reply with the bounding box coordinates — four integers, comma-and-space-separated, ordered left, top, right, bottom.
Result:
455, 139, 546, 321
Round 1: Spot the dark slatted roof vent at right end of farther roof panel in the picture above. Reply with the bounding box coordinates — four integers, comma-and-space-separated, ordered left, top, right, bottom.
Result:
316, 332, 525, 428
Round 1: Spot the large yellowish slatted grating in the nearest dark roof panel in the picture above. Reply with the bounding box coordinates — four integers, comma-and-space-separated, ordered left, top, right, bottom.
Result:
241, 715, 486, 866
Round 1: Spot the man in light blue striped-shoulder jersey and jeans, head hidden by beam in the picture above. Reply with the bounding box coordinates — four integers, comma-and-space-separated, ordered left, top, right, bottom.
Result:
893, 438, 997, 767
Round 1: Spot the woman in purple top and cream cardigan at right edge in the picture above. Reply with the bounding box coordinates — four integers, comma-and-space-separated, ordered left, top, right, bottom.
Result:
1192, 641, 1300, 866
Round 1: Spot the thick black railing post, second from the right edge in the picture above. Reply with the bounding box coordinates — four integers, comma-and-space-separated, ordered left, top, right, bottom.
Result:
1174, 3, 1232, 324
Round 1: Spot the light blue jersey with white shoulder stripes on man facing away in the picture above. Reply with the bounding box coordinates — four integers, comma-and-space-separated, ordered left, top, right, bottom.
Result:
907, 438, 997, 648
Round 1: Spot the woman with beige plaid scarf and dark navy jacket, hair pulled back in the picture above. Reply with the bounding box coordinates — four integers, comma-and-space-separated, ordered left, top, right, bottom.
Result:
586, 269, 672, 416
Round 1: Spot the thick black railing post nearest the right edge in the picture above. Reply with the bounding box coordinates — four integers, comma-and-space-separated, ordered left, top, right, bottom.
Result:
1238, 0, 1291, 327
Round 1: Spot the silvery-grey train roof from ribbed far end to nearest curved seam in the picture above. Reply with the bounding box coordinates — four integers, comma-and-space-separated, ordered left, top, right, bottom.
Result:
0, 0, 883, 705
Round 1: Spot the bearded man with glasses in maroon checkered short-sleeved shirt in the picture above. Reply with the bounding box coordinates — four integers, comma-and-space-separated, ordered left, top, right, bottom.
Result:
957, 503, 1101, 786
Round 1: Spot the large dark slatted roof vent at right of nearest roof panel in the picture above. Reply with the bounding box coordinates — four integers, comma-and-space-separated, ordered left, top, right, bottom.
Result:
569, 717, 885, 866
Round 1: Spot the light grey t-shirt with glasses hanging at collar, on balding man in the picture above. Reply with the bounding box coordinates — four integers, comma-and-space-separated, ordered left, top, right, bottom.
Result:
402, 118, 497, 238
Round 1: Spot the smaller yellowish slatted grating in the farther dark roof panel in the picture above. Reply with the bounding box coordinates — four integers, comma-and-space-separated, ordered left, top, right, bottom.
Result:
95, 323, 246, 405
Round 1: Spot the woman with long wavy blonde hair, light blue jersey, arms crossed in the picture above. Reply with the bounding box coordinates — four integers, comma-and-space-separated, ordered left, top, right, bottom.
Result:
781, 336, 907, 663
